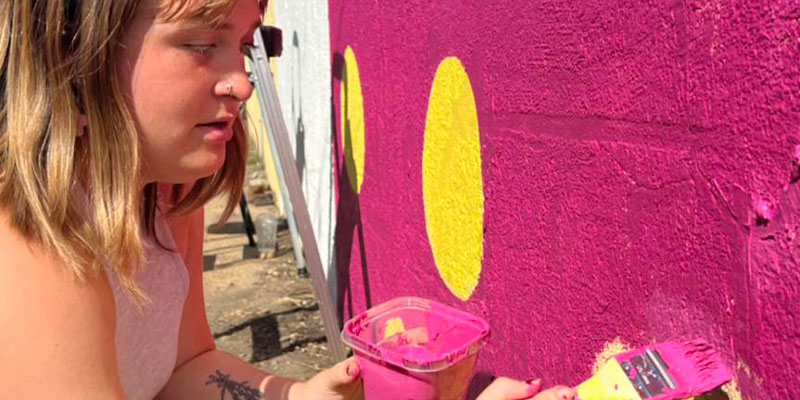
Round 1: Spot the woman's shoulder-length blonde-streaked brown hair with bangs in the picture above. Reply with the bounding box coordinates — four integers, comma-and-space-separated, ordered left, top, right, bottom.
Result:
0, 0, 263, 297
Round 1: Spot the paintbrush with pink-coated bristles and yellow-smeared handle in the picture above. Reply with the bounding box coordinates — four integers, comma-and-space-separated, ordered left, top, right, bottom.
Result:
577, 339, 731, 400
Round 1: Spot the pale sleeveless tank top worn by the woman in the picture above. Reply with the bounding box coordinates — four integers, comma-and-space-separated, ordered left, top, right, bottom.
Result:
108, 215, 189, 400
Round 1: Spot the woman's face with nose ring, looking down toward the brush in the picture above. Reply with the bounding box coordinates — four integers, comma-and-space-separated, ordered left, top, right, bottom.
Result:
119, 0, 260, 183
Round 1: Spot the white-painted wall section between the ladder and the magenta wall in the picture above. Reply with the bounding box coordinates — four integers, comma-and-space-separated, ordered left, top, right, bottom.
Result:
274, 0, 336, 281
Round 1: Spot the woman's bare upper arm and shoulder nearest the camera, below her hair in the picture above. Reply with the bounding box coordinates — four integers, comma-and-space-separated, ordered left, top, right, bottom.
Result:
0, 211, 124, 400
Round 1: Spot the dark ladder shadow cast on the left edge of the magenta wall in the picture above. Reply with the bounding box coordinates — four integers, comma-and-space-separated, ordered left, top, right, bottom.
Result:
331, 52, 372, 321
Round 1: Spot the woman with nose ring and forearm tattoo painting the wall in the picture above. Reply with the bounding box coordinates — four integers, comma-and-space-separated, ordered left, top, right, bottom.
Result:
0, 0, 572, 400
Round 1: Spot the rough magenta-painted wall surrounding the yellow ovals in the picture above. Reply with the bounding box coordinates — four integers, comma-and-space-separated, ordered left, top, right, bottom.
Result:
330, 0, 800, 399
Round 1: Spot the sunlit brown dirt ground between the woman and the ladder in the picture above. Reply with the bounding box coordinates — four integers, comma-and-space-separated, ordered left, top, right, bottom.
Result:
203, 164, 333, 379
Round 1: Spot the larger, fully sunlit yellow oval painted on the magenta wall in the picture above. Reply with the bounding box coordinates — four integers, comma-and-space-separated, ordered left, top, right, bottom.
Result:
422, 57, 483, 301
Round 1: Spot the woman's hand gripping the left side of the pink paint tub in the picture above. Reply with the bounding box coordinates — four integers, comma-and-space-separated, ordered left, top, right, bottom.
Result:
293, 357, 364, 400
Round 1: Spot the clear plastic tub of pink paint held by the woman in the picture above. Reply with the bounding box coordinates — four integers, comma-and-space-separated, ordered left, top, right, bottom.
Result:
342, 297, 489, 400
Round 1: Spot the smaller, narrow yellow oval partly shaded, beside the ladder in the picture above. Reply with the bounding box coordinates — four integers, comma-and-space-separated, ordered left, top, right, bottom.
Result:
340, 46, 364, 193
